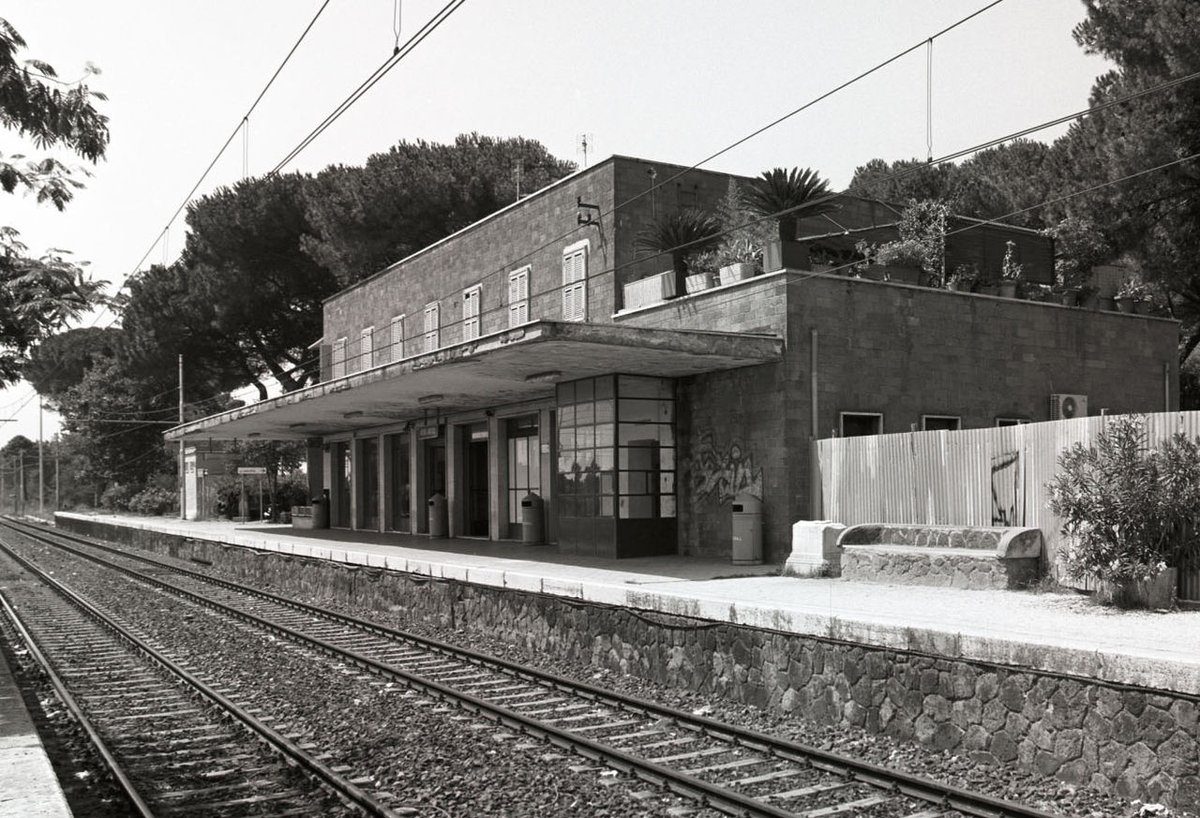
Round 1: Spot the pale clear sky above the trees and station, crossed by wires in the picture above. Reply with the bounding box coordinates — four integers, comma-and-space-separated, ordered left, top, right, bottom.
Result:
0, 0, 1109, 441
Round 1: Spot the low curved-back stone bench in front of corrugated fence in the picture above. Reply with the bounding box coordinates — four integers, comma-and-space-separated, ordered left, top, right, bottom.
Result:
838, 524, 1042, 589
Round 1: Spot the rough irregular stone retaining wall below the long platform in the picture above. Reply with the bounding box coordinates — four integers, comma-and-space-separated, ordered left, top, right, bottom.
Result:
59, 518, 1200, 808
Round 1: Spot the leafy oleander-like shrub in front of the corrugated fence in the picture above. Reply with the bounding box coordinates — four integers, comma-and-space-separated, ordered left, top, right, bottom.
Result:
1048, 415, 1200, 583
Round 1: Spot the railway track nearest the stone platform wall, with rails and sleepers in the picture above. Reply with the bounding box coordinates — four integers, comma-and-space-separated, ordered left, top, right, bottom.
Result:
5, 521, 1065, 818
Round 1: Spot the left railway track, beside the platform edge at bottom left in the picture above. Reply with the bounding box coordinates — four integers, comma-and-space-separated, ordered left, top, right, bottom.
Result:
0, 532, 403, 818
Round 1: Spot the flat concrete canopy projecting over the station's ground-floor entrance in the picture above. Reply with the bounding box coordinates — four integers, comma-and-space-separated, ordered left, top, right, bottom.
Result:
166, 321, 784, 440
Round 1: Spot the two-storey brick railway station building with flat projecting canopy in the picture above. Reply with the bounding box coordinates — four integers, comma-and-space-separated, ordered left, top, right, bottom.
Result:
167, 156, 1178, 561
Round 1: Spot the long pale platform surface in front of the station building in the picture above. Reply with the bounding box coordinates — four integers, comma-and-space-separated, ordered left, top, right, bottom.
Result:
60, 513, 1200, 694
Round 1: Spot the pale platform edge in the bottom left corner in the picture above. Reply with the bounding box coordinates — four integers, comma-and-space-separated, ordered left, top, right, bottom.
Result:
0, 638, 71, 818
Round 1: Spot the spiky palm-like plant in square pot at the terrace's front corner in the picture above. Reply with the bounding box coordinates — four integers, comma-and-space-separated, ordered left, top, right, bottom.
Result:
744, 168, 838, 272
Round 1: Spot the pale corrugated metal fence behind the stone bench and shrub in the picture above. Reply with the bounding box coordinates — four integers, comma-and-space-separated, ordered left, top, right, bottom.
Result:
817, 411, 1200, 601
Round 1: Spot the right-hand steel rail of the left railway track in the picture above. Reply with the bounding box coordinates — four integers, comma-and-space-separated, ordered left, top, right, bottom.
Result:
0, 533, 398, 818
